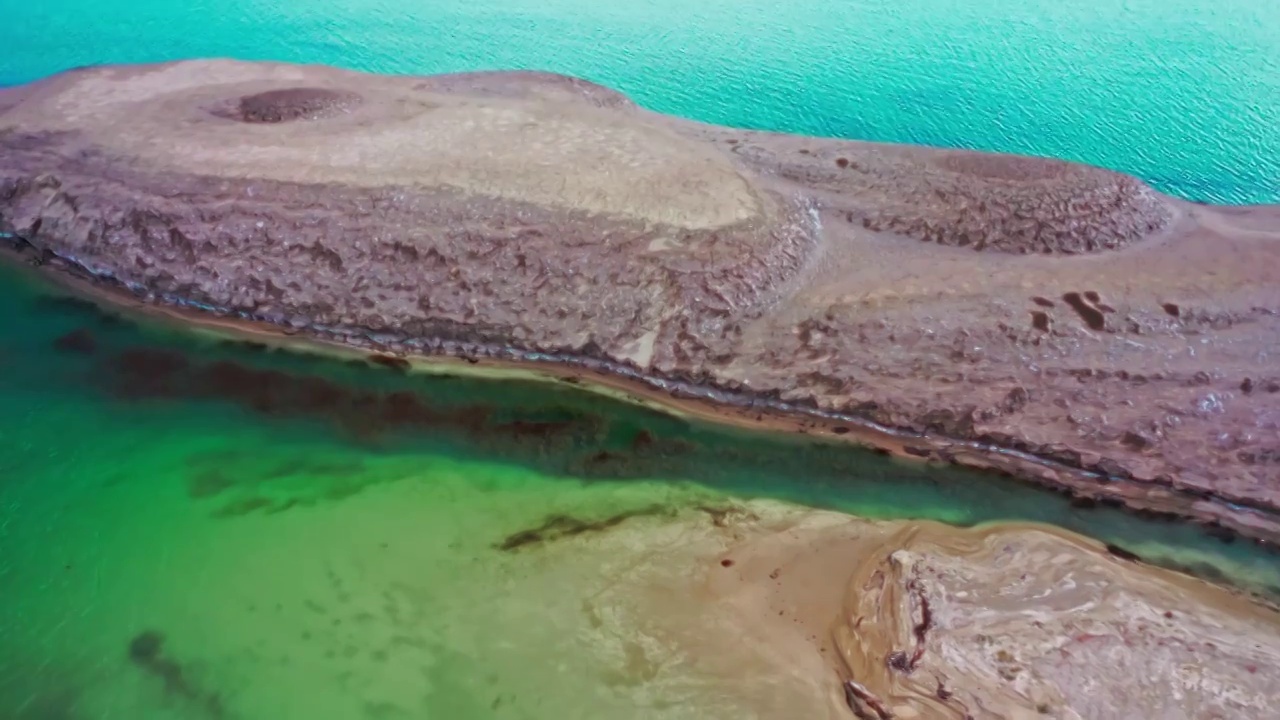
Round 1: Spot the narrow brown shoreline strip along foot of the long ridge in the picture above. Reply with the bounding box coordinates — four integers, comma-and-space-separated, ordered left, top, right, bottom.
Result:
0, 236, 1280, 551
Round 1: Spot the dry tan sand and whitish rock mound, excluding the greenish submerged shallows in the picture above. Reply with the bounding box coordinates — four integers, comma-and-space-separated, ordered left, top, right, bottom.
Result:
691, 504, 1280, 719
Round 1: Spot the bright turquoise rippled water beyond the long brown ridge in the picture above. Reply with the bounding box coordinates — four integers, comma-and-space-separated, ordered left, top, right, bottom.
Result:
0, 0, 1280, 204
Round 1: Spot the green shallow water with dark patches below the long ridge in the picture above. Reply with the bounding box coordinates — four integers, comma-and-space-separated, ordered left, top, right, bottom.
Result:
0, 258, 1280, 720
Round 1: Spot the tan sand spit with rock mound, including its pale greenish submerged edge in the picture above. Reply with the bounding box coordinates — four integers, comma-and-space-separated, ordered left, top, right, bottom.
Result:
512, 502, 1280, 720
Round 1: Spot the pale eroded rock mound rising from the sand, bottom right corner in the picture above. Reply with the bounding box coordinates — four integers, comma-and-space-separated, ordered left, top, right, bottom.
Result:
836, 525, 1280, 720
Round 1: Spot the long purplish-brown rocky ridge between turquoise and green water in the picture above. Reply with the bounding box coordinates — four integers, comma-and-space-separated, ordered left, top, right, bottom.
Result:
0, 61, 1280, 541
